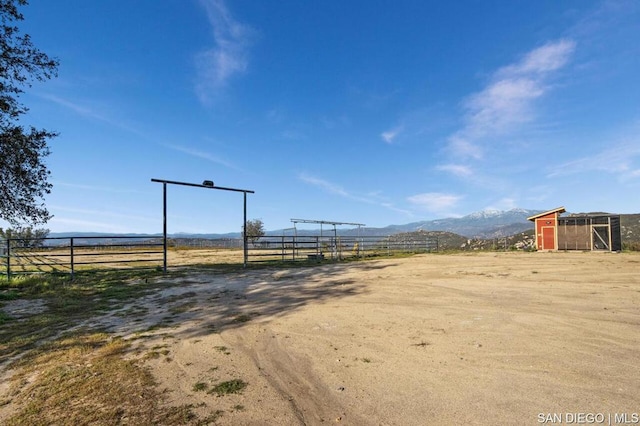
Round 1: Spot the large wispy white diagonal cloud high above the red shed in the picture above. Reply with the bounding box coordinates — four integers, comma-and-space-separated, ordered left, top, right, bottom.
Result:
448, 39, 576, 159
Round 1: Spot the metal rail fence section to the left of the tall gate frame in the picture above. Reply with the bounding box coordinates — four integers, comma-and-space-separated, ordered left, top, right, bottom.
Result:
0, 236, 163, 280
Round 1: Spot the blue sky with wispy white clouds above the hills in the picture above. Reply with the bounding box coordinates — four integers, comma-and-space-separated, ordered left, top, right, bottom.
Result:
0, 0, 640, 233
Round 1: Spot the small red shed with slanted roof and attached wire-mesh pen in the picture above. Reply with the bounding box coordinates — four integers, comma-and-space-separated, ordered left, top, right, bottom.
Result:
527, 207, 622, 251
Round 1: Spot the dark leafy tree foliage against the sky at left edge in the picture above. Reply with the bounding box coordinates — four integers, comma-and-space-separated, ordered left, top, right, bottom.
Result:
0, 0, 58, 225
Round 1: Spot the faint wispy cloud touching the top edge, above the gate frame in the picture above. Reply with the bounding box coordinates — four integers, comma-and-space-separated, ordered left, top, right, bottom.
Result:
196, 0, 255, 102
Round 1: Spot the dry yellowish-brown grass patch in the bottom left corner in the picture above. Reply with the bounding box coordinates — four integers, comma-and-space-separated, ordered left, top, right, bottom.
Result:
3, 333, 215, 425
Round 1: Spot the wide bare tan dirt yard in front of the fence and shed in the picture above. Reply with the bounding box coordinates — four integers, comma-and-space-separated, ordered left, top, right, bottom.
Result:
0, 253, 640, 425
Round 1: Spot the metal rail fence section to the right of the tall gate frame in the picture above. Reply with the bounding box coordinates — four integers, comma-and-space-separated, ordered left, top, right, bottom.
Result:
248, 235, 438, 262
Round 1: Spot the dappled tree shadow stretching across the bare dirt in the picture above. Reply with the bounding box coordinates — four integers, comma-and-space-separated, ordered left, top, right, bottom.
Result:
85, 262, 392, 338
